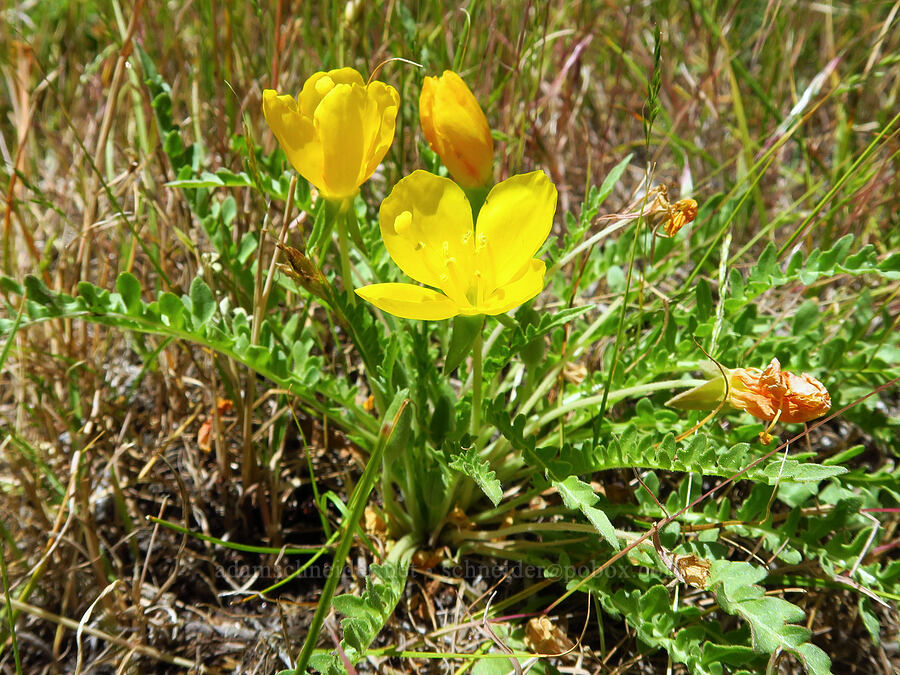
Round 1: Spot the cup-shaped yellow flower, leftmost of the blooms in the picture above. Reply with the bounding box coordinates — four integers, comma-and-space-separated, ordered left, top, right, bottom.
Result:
263, 68, 400, 201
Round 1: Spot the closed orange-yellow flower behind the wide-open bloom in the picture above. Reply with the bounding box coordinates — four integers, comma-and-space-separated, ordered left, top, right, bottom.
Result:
419, 70, 494, 188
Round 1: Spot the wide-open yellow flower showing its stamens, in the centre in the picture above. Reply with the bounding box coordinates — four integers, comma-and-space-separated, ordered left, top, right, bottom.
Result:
356, 171, 556, 320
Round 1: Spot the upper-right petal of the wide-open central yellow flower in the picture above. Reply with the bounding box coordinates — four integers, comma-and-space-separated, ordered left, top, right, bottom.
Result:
475, 171, 556, 295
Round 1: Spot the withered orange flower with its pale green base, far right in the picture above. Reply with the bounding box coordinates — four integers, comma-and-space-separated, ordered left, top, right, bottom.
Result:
666, 359, 831, 423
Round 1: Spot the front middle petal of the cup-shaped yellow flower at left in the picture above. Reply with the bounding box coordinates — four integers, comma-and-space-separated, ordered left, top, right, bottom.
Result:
315, 84, 368, 200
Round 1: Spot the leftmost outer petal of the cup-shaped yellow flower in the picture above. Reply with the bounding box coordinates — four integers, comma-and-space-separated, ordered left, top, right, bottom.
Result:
263, 89, 323, 186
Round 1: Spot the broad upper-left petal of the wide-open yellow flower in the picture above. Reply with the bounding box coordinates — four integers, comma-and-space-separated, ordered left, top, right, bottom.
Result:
378, 170, 477, 307
